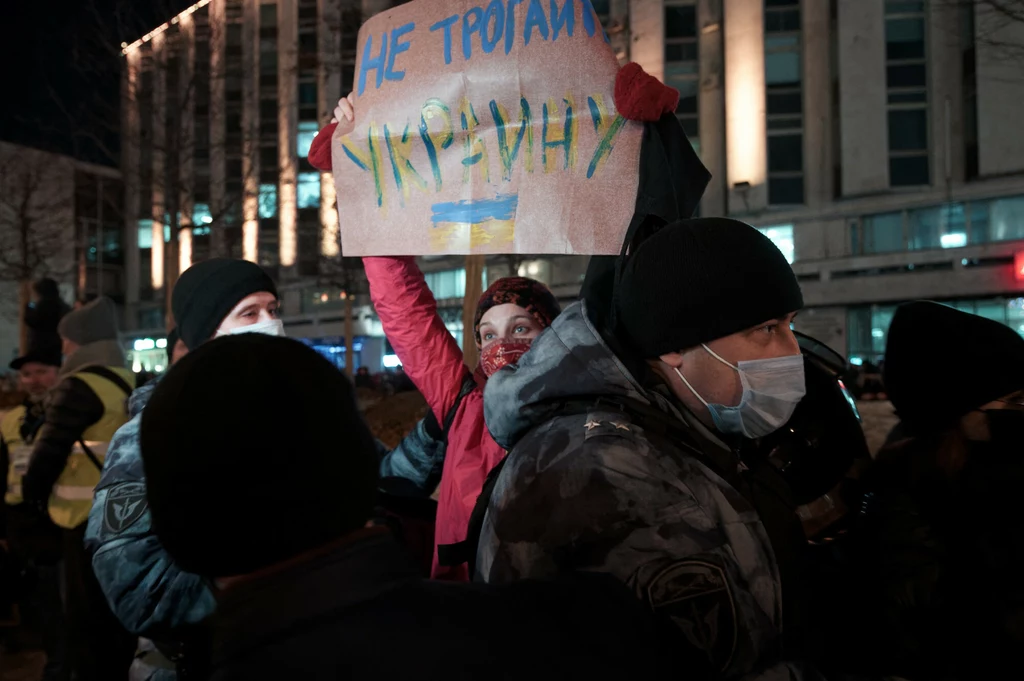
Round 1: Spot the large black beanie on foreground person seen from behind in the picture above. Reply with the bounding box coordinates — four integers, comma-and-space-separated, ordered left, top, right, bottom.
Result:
140, 334, 379, 578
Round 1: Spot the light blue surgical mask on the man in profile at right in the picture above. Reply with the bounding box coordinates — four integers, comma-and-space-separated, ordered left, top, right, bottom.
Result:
676, 345, 807, 439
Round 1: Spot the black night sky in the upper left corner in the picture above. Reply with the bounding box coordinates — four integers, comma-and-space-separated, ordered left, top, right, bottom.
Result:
0, 0, 195, 166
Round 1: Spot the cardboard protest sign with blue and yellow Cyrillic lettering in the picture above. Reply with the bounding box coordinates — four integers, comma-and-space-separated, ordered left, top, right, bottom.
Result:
332, 0, 642, 255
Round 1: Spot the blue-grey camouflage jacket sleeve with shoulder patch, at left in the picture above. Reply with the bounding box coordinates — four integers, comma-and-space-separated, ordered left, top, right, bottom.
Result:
85, 412, 214, 640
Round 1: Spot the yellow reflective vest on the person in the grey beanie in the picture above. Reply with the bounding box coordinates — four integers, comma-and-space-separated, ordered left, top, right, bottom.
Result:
48, 367, 135, 529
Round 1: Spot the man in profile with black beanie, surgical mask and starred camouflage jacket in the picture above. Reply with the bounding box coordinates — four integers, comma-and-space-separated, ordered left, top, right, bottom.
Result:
477, 218, 823, 679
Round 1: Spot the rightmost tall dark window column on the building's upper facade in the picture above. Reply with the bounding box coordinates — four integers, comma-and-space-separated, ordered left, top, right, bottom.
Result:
886, 0, 931, 186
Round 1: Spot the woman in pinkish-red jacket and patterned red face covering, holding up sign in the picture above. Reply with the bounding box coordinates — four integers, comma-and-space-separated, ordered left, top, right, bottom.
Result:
309, 63, 679, 581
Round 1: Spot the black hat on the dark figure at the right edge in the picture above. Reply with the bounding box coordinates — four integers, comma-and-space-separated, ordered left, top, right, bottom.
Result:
883, 300, 1024, 434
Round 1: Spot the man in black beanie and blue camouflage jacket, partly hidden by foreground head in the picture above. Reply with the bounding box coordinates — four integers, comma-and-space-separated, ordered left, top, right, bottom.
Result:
85, 258, 284, 680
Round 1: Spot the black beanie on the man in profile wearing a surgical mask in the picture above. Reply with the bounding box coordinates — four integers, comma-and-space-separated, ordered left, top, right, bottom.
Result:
615, 217, 804, 359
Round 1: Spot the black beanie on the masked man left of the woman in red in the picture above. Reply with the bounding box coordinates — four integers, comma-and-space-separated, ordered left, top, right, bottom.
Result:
171, 258, 278, 350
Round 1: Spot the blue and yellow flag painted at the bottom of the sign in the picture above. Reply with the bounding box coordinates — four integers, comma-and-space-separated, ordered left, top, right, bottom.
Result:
430, 194, 519, 253
